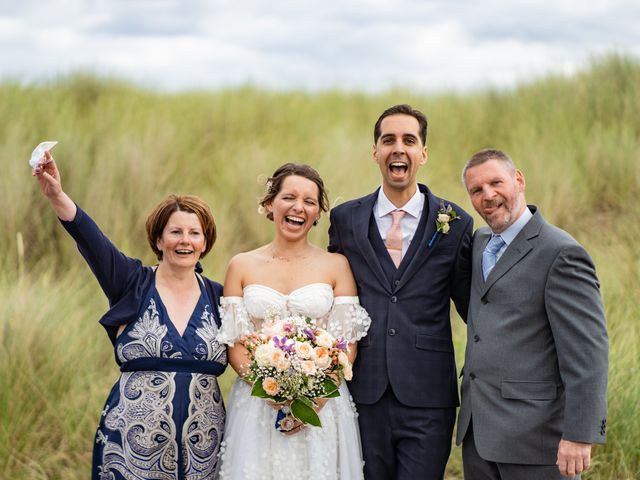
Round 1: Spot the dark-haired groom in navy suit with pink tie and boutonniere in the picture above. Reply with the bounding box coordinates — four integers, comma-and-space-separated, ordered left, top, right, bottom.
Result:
329, 105, 473, 480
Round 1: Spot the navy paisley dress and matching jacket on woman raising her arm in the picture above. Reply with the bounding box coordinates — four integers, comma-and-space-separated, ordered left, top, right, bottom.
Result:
61, 207, 227, 480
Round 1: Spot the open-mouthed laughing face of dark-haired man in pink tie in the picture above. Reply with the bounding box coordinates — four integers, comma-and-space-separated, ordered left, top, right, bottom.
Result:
373, 114, 427, 193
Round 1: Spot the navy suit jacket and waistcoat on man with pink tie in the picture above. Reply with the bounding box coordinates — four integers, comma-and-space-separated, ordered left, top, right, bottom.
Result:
329, 184, 473, 408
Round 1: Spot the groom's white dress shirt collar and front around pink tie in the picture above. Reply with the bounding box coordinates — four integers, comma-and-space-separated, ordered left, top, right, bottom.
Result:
373, 185, 425, 257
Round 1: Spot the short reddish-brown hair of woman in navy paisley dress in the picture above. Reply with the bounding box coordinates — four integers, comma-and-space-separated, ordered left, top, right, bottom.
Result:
146, 194, 216, 260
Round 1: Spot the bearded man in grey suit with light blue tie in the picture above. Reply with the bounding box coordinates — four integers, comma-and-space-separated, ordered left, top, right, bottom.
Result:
456, 150, 608, 480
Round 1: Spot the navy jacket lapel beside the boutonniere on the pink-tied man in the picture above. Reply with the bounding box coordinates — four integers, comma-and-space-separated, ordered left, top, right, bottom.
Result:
394, 184, 440, 290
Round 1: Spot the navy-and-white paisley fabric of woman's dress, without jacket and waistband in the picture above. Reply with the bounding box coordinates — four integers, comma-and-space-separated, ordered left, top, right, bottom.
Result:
93, 280, 227, 480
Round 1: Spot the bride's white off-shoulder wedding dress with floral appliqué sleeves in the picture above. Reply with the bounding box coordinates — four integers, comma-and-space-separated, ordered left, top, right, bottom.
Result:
218, 283, 371, 480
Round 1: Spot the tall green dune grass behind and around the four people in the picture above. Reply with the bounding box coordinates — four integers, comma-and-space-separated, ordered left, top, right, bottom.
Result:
0, 56, 640, 480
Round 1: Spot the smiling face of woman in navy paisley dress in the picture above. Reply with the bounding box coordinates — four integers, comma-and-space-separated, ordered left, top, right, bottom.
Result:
156, 211, 207, 268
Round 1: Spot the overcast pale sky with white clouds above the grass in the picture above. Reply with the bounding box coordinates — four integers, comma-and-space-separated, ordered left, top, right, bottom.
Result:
0, 0, 640, 92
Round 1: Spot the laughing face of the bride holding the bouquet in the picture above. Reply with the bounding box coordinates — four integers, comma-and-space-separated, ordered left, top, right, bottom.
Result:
267, 175, 320, 240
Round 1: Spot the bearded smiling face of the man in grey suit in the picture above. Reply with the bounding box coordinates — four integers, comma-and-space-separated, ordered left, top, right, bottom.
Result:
464, 160, 526, 233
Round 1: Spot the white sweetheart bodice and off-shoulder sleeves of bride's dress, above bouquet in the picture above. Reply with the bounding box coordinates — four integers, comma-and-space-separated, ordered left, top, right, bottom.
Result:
218, 283, 371, 345
